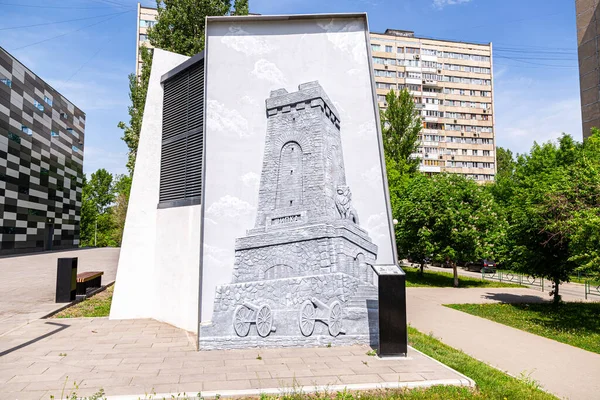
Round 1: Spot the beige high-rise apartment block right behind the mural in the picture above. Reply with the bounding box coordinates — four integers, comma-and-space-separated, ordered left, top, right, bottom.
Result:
371, 29, 496, 183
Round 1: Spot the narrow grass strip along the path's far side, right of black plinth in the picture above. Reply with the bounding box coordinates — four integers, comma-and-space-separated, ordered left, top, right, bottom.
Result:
404, 268, 524, 288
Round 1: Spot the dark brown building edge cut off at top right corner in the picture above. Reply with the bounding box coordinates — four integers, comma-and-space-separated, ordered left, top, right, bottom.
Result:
575, 0, 600, 139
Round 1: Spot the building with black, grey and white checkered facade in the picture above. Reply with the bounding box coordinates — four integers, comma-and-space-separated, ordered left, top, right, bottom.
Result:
0, 47, 85, 255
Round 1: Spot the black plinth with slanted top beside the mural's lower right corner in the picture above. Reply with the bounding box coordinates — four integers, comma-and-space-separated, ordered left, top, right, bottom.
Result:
374, 266, 408, 357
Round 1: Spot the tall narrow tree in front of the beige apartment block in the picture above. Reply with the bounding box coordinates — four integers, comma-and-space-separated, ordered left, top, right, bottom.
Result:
381, 89, 423, 174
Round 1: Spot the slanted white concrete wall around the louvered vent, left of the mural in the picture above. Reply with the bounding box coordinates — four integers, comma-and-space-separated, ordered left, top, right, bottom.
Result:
110, 49, 200, 332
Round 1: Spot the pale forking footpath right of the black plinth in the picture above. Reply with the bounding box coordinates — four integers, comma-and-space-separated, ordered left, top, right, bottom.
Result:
407, 288, 600, 400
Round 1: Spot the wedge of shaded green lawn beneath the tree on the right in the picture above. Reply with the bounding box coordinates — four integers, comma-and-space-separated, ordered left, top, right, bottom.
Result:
447, 303, 600, 354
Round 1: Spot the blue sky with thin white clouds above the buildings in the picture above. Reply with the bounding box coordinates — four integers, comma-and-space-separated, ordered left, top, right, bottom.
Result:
0, 0, 582, 173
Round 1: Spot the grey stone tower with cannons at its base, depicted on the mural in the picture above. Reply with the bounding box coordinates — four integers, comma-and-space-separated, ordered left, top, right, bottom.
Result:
200, 82, 377, 349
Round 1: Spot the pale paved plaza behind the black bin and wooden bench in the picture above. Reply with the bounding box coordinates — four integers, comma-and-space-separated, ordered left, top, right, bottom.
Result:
0, 248, 120, 337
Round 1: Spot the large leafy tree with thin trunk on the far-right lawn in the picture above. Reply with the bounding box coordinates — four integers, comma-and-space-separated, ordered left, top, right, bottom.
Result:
509, 135, 600, 303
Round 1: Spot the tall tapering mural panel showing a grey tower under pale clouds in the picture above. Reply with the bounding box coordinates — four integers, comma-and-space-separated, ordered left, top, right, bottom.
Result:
200, 16, 395, 349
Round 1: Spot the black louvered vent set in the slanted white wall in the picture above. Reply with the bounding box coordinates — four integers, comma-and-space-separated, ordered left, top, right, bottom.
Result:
159, 62, 204, 207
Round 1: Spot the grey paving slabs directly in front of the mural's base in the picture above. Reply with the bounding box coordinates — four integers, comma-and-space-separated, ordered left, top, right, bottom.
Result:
0, 318, 473, 400
